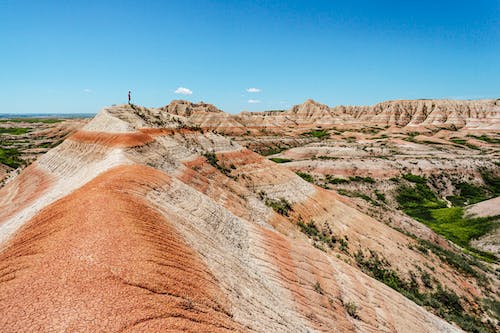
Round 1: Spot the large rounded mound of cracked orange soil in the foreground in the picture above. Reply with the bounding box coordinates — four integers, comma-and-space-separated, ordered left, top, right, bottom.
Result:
0, 166, 241, 332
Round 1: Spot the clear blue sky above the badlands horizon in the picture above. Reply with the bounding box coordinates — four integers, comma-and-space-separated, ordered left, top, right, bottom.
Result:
0, 0, 500, 113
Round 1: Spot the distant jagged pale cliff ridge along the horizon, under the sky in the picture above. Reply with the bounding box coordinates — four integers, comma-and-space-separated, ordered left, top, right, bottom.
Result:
163, 100, 500, 134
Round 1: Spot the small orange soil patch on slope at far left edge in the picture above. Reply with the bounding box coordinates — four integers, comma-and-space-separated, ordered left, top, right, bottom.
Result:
0, 163, 52, 224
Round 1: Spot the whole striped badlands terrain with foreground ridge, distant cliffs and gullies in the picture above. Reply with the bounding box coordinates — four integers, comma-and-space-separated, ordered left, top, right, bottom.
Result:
0, 101, 500, 332
